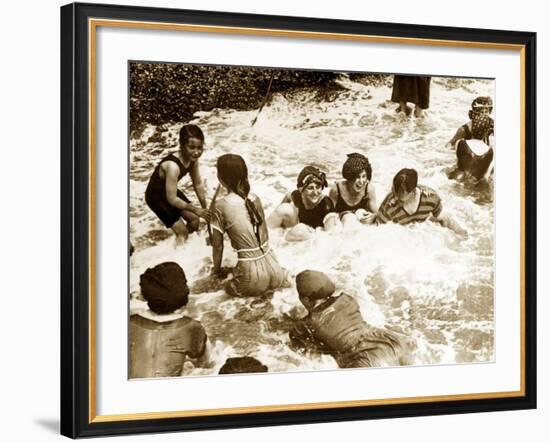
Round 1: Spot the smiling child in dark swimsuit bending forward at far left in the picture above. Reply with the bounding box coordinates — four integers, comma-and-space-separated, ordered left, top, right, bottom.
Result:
145, 124, 210, 243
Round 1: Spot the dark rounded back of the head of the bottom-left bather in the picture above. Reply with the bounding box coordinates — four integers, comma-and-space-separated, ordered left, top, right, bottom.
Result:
139, 262, 189, 315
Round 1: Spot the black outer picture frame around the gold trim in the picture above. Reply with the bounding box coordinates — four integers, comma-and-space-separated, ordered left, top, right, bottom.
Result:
60, 3, 537, 438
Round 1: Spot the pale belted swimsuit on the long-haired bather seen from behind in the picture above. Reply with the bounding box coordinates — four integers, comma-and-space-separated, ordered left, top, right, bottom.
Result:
211, 193, 287, 296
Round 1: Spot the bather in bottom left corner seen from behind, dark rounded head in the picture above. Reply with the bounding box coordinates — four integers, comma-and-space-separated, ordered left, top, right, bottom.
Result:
129, 262, 210, 378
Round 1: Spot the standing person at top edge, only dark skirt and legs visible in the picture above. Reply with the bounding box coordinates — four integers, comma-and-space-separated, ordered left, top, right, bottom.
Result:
391, 75, 431, 118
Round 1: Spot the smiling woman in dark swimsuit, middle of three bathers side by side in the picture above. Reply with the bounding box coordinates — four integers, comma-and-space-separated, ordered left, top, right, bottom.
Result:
326, 153, 378, 226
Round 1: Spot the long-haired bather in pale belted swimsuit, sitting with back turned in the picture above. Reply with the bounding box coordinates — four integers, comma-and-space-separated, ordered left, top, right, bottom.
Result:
210, 154, 288, 296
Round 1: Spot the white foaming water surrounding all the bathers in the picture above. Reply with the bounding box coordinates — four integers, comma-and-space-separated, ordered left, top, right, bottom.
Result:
129, 75, 494, 375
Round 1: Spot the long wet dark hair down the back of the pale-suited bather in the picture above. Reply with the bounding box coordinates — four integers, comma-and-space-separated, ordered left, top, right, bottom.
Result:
216, 153, 264, 253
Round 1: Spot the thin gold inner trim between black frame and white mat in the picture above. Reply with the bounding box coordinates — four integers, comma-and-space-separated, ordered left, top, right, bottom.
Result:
88, 18, 526, 423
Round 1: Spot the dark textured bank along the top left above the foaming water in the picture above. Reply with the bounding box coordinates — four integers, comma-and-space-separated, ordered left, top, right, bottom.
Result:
130, 62, 392, 137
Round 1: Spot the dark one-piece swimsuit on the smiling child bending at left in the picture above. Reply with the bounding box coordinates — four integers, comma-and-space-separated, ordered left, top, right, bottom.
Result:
145, 153, 193, 228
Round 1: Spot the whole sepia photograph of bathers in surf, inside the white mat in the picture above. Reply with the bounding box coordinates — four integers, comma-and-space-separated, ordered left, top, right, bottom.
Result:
128, 61, 496, 379
